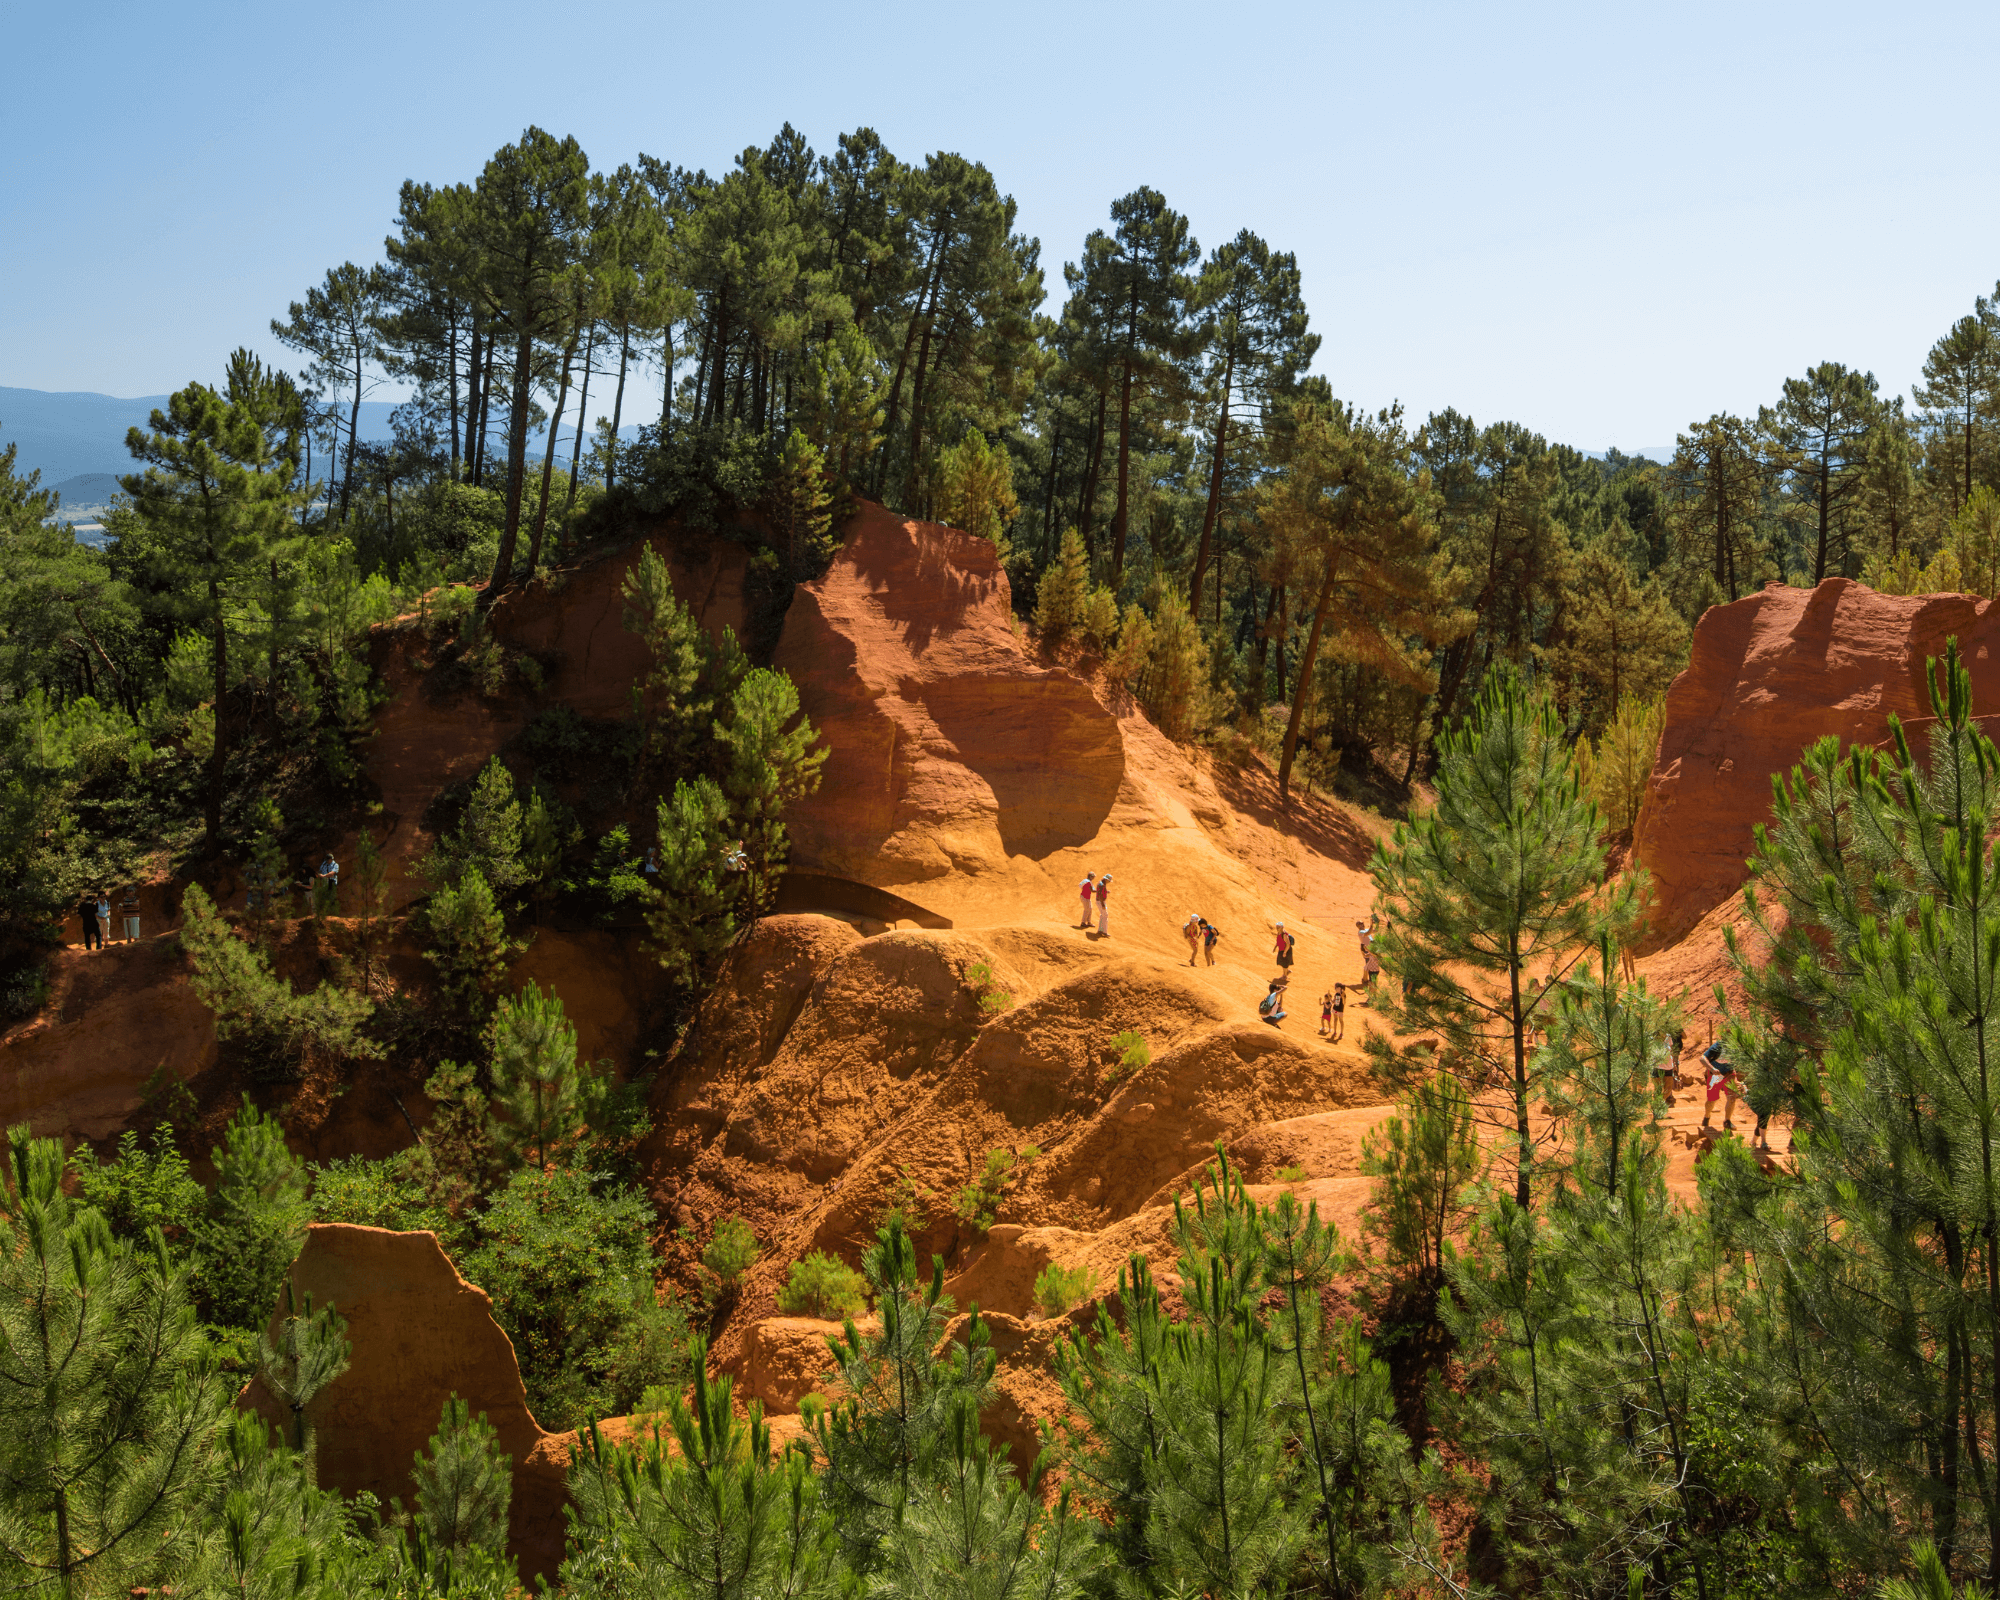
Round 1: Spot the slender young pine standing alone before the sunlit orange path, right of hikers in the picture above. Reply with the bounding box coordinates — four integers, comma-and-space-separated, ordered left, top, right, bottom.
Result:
1368, 666, 1636, 1208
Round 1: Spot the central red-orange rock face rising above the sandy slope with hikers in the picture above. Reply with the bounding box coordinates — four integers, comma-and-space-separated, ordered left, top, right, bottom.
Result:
776, 506, 1124, 888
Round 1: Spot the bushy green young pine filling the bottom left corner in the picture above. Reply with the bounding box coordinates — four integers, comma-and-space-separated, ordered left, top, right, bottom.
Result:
0, 1126, 228, 1600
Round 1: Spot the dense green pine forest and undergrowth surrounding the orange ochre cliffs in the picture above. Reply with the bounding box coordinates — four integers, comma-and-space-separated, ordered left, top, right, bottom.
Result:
0, 128, 2000, 1600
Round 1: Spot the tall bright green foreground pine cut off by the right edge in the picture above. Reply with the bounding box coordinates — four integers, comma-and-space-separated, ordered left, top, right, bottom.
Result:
1730, 640, 2000, 1584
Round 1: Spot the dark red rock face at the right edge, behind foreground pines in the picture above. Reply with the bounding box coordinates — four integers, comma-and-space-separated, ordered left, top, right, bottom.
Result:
1634, 578, 2000, 948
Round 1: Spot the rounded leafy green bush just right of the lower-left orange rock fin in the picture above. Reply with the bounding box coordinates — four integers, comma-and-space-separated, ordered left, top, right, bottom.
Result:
464, 1168, 686, 1430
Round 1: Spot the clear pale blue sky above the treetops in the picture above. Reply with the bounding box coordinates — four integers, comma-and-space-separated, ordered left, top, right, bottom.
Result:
0, 0, 2000, 450
